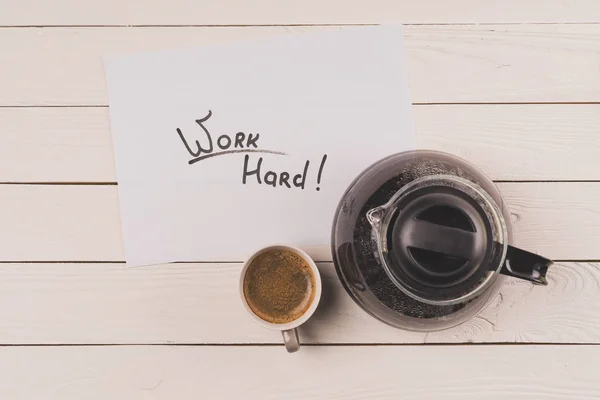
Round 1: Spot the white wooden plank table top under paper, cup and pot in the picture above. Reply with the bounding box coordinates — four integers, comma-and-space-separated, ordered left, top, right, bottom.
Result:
0, 0, 600, 400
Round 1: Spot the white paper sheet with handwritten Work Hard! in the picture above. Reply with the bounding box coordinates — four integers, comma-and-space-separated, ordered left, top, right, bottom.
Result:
106, 26, 416, 266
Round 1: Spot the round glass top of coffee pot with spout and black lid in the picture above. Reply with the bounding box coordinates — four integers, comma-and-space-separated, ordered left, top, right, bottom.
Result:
366, 175, 507, 305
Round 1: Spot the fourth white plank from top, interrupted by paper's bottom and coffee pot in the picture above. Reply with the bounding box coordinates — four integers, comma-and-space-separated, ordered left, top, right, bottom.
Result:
0, 183, 600, 261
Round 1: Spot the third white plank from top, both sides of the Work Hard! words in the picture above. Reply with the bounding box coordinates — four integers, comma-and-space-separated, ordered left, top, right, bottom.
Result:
0, 104, 600, 182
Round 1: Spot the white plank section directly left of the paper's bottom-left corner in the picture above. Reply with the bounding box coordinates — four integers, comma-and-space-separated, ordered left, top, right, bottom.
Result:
0, 185, 124, 261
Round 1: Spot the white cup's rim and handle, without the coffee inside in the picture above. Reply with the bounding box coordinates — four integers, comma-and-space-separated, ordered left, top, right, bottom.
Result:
239, 245, 322, 353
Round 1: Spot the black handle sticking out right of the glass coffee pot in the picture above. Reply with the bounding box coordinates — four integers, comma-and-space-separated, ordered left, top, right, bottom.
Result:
500, 246, 553, 286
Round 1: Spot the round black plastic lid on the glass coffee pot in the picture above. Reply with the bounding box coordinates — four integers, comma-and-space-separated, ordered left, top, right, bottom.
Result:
387, 186, 493, 298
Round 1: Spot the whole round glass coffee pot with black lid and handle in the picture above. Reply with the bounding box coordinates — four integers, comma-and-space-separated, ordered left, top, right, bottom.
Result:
332, 150, 552, 331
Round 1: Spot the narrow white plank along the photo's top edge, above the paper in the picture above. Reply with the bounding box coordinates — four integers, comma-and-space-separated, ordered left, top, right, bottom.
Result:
0, 0, 600, 26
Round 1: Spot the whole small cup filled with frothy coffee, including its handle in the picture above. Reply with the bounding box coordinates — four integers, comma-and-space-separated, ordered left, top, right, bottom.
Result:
240, 246, 321, 352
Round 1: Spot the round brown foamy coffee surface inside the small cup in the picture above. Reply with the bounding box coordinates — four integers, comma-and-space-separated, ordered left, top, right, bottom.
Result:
244, 250, 316, 324
